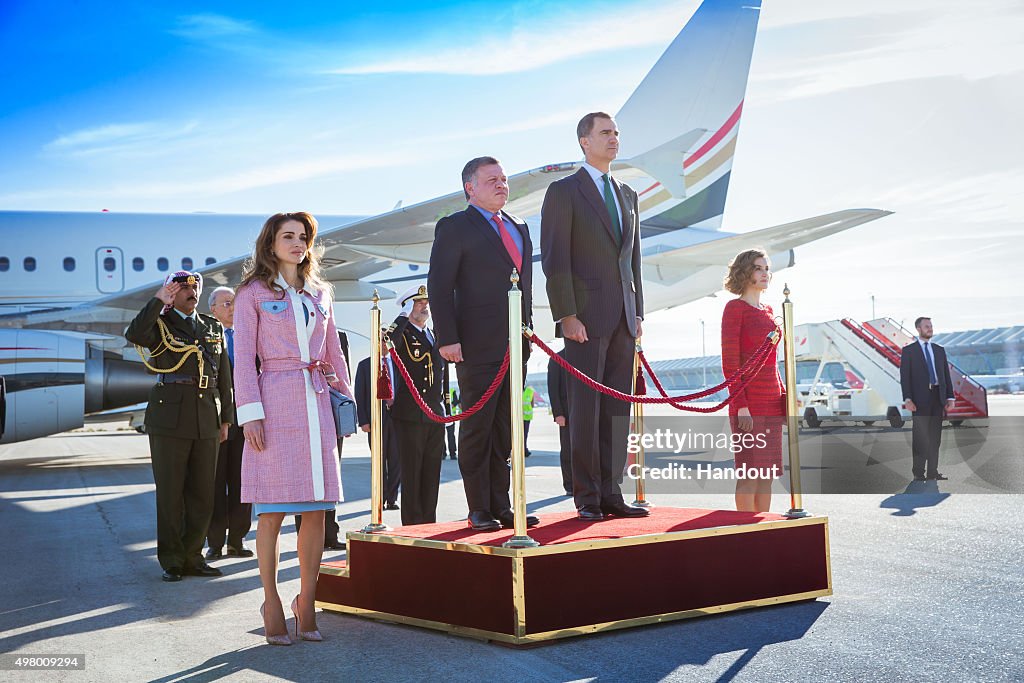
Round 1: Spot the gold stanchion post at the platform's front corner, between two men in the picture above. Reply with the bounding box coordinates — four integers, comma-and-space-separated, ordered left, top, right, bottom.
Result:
502, 268, 541, 548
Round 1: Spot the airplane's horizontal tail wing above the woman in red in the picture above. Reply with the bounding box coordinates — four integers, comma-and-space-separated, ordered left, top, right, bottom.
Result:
643, 209, 892, 285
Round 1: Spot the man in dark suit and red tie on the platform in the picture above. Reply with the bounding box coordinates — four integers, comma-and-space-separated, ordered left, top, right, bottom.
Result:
427, 157, 537, 530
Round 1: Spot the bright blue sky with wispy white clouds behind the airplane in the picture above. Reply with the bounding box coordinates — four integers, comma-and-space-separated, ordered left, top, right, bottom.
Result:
0, 0, 1024, 356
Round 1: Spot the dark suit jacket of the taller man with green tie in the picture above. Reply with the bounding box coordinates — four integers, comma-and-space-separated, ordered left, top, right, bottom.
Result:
541, 168, 643, 337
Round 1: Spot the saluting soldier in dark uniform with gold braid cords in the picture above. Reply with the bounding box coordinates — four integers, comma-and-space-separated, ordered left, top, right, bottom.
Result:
125, 270, 234, 582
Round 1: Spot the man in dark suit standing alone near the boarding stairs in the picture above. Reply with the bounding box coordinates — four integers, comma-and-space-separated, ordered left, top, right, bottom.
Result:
899, 317, 956, 481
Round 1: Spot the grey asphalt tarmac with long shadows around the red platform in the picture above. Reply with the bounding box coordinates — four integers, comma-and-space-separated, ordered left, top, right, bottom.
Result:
0, 403, 1024, 682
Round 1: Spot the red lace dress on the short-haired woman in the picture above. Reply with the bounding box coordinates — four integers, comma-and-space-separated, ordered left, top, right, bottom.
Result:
722, 299, 785, 471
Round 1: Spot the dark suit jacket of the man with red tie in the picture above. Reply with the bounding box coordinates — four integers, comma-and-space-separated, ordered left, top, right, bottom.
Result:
427, 206, 534, 365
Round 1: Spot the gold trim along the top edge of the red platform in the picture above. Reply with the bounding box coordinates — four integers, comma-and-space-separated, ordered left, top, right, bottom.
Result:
339, 515, 828, 557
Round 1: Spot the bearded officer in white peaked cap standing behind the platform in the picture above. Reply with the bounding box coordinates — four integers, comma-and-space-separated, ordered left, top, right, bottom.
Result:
390, 285, 447, 524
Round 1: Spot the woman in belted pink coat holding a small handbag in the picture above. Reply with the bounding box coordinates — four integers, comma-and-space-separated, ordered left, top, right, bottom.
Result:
234, 212, 353, 645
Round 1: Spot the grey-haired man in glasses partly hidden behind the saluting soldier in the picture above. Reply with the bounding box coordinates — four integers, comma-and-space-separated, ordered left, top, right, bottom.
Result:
206, 287, 253, 560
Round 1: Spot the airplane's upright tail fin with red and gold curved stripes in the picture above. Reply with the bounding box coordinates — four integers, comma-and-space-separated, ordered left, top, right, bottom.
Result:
615, 0, 761, 229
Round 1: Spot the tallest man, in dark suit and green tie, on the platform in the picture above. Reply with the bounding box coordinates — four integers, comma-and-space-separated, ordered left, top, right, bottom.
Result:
541, 112, 648, 521
